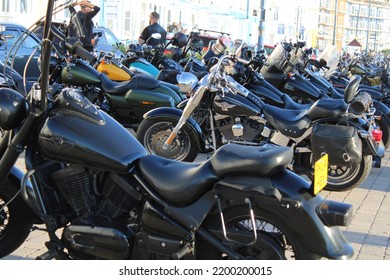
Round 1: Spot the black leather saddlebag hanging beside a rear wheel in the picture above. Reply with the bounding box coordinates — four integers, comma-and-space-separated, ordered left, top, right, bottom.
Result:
311, 124, 363, 167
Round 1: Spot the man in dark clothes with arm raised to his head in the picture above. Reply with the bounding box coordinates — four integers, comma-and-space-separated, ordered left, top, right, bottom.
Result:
69, 0, 100, 52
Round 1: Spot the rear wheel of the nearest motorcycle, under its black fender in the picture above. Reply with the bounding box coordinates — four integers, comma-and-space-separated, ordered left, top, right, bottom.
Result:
195, 205, 320, 260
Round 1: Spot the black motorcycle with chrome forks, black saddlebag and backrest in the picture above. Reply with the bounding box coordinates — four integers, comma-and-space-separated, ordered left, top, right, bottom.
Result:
137, 48, 384, 191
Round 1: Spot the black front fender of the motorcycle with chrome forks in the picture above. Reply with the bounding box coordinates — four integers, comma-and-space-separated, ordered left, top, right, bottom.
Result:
144, 107, 205, 150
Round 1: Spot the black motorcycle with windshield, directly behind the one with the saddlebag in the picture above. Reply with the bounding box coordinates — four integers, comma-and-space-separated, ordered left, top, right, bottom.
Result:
260, 42, 390, 148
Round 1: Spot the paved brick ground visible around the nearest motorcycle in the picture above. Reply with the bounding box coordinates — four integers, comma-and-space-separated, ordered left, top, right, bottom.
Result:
1, 151, 390, 260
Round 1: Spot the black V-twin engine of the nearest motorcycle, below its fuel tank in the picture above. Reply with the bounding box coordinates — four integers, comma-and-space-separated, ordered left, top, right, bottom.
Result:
52, 165, 143, 259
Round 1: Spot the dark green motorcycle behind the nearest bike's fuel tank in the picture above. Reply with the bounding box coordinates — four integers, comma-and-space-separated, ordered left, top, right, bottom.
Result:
34, 23, 186, 130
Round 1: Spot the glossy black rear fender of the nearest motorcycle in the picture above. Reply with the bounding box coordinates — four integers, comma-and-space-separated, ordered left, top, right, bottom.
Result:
212, 171, 353, 259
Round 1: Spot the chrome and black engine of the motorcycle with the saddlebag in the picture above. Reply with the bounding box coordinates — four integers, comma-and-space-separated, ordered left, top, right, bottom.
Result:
216, 115, 264, 143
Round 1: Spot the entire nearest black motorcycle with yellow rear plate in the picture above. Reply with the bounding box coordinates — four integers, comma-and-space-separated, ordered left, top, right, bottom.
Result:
0, 0, 353, 259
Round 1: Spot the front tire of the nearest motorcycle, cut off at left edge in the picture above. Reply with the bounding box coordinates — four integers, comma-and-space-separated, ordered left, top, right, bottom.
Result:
0, 183, 32, 258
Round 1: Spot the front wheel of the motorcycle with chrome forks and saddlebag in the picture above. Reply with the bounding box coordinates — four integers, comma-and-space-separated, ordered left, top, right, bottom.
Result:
137, 117, 199, 162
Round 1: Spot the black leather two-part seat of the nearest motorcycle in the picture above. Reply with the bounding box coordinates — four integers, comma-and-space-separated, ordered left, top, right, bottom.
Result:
139, 144, 293, 205
